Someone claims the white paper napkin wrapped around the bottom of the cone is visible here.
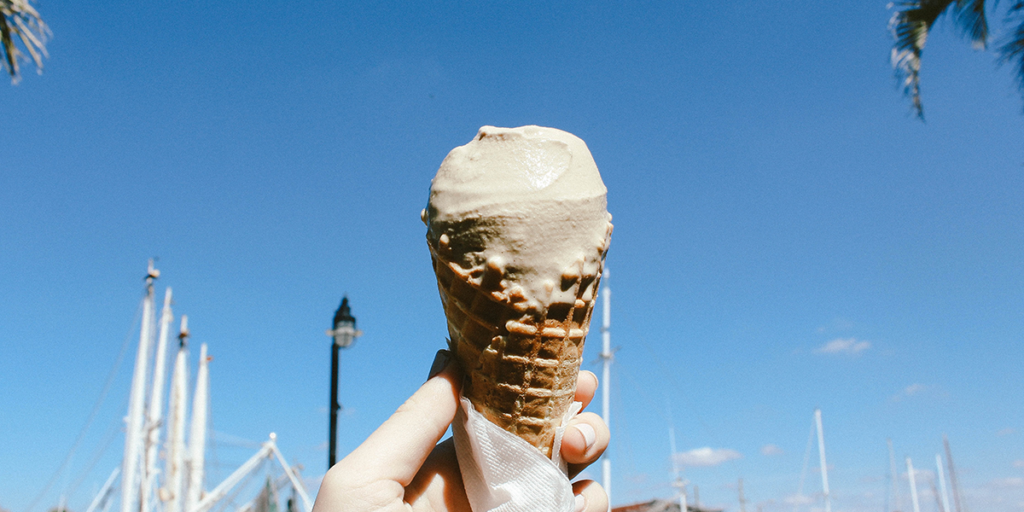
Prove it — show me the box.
[452,397,583,512]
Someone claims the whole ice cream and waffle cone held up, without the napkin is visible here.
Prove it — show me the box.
[423,126,611,457]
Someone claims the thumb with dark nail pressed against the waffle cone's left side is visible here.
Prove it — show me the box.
[338,350,462,486]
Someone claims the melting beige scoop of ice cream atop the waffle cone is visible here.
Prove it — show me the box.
[423,126,611,311]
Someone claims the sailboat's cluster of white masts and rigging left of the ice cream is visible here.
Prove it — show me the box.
[86,260,312,512]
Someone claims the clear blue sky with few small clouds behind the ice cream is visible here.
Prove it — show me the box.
[0,1,1024,512]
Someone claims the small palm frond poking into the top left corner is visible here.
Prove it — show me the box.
[0,0,50,83]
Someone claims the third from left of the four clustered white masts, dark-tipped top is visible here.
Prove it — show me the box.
[161,315,188,512]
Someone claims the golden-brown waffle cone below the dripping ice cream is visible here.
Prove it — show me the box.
[429,240,601,457]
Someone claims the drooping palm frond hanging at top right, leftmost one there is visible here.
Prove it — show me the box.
[889,0,958,120]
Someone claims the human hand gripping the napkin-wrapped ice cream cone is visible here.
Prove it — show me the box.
[313,350,609,512]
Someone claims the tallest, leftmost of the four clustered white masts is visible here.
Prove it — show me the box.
[121,259,160,512]
